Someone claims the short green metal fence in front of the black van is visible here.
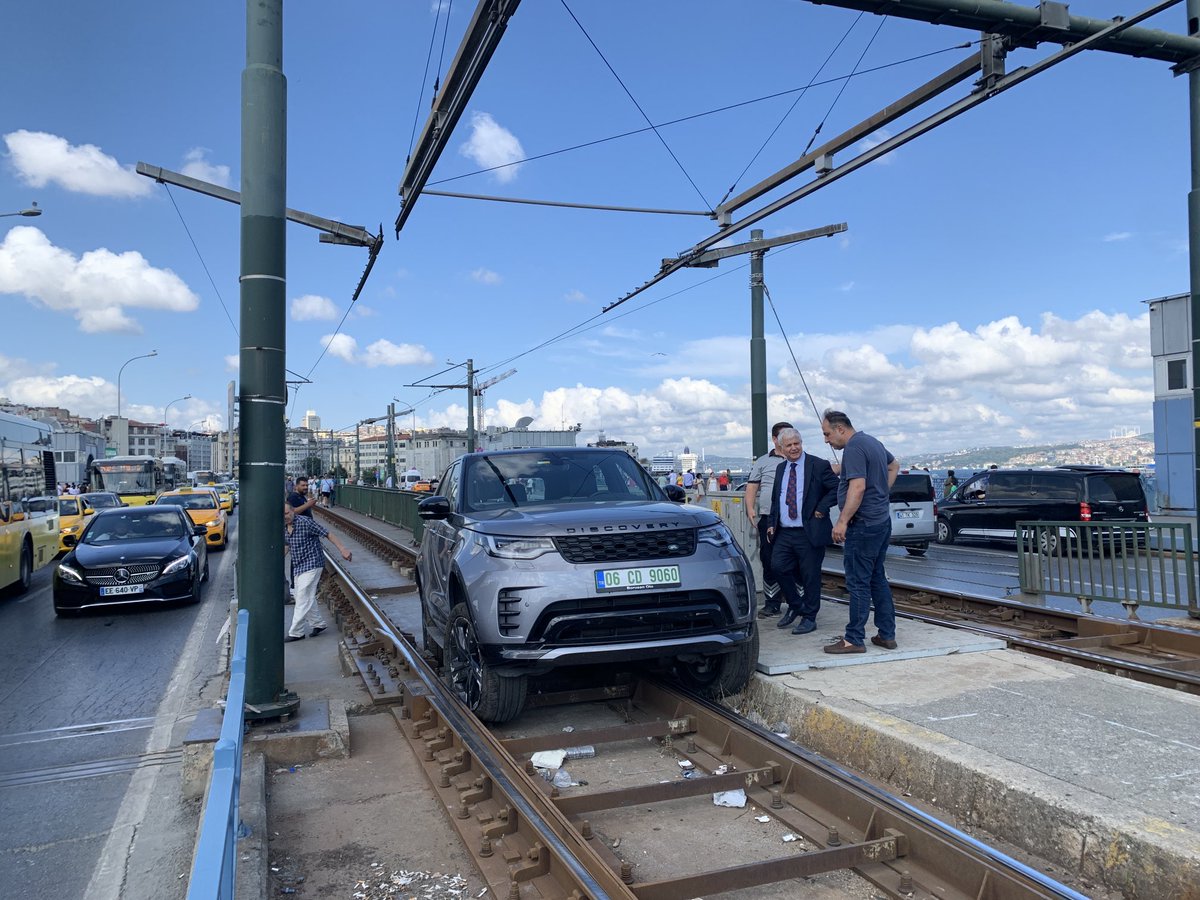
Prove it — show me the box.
[1016,522,1200,619]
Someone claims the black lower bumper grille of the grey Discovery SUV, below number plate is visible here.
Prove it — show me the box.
[529,590,734,646]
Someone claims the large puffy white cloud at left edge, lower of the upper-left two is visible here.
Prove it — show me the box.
[0,226,200,334]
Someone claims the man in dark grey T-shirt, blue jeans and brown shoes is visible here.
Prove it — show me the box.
[821,409,900,653]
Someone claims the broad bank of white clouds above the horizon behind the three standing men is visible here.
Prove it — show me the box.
[504,311,1153,461]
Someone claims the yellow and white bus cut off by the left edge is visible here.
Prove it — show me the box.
[0,413,59,593]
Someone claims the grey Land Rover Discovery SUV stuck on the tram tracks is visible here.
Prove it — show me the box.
[416,448,758,722]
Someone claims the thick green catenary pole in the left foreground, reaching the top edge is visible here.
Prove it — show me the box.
[238,0,300,718]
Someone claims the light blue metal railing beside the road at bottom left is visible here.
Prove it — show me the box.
[187,610,250,900]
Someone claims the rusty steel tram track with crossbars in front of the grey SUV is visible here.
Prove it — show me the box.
[314,511,1082,900]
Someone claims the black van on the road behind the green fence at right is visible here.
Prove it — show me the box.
[936,466,1150,554]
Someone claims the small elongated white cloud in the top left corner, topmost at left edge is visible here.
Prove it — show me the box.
[4,128,154,197]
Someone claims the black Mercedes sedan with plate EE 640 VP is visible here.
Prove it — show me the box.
[54,505,209,616]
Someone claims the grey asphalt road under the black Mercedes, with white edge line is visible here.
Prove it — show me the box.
[0,515,238,900]
